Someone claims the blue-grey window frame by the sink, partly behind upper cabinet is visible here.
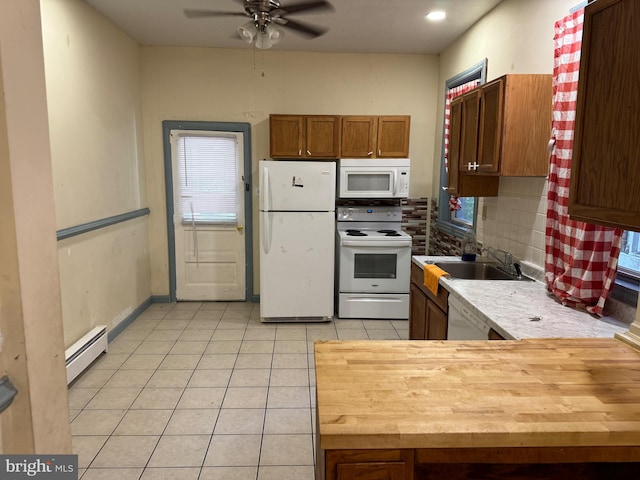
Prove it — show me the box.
[436,58,487,238]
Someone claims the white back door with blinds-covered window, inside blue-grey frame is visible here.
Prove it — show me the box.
[171,130,246,301]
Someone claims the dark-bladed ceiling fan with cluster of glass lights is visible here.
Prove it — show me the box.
[184,0,333,49]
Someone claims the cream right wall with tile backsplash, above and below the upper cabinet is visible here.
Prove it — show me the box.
[433,0,579,267]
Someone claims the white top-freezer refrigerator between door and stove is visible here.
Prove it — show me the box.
[259,160,336,322]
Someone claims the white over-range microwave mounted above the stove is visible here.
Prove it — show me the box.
[337,158,410,198]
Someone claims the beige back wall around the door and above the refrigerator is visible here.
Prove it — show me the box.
[142,47,438,295]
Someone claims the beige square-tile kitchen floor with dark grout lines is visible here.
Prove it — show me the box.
[69,302,408,480]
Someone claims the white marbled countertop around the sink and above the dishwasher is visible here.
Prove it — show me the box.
[412,256,629,340]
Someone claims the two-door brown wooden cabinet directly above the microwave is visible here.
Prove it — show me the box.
[340,115,411,158]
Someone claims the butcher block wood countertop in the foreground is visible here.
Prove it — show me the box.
[315,338,640,454]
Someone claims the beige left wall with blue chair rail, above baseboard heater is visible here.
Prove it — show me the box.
[41,0,151,346]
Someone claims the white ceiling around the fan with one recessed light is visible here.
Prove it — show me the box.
[84,0,502,54]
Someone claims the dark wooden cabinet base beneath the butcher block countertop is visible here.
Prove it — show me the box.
[316,447,640,480]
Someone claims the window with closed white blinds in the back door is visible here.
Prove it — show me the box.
[177,132,238,224]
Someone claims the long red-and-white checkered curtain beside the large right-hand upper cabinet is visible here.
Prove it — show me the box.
[545,9,622,315]
